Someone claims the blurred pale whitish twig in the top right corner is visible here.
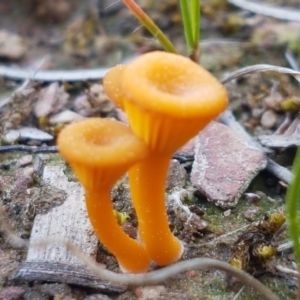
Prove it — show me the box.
[227,0,300,22]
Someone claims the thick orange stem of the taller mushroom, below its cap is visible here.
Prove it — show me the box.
[129,154,183,266]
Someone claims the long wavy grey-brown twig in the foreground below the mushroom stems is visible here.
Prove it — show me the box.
[34,239,279,300]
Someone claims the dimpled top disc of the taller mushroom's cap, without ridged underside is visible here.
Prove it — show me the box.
[121,51,227,119]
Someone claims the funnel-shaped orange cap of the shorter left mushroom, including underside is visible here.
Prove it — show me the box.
[58,118,148,189]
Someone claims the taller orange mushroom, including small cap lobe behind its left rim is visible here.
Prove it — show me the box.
[104,51,228,266]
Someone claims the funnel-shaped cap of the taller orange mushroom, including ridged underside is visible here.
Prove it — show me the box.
[117,51,228,155]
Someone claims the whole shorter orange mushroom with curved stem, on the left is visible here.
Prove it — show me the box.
[58,118,150,273]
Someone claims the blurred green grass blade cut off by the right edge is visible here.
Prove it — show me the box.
[286,147,300,265]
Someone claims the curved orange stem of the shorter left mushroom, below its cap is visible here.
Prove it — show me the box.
[86,189,149,273]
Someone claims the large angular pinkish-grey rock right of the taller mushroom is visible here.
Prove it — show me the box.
[191,122,267,209]
